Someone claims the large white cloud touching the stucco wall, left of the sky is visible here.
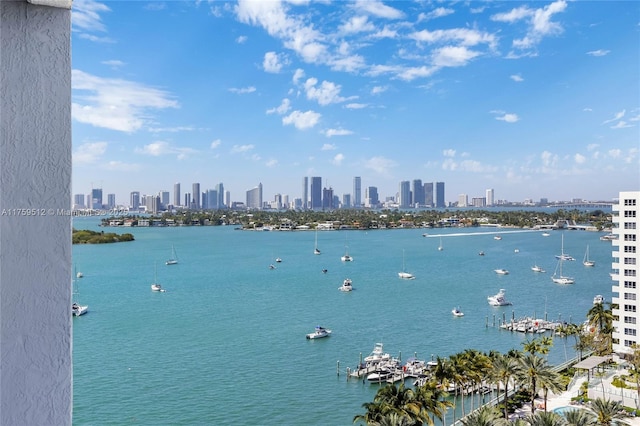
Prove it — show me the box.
[71,70,179,132]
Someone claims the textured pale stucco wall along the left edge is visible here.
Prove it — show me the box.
[0,0,72,426]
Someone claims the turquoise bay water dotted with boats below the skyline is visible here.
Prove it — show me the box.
[73,218,611,425]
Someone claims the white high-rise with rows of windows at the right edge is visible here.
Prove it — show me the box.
[611,191,640,354]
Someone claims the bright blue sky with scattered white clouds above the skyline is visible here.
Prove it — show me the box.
[72,0,640,204]
